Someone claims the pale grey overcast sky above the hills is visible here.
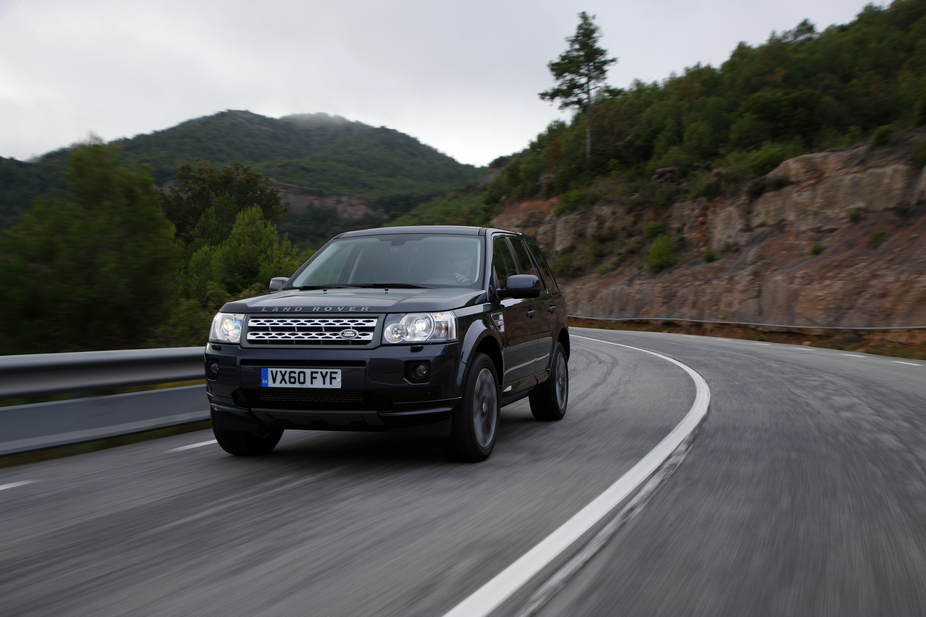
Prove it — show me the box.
[0,0,881,165]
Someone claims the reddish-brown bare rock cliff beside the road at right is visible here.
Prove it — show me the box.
[494,146,926,327]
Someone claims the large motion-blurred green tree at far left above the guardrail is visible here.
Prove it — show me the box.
[0,141,177,354]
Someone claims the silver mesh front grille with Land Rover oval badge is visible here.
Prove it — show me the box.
[247,316,379,347]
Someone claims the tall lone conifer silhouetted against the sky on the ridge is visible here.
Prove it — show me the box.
[540,11,617,158]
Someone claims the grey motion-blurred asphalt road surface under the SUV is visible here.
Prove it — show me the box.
[0,328,926,616]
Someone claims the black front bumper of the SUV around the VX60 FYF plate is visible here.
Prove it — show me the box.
[205,342,463,435]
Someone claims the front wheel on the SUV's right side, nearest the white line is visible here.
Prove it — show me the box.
[444,353,499,463]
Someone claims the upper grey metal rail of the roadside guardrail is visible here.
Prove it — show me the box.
[0,347,205,399]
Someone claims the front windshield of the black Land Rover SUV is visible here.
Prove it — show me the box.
[290,234,485,288]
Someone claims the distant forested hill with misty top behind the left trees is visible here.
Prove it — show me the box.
[0,111,479,229]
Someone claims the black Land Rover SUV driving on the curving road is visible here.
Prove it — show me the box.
[205,226,569,461]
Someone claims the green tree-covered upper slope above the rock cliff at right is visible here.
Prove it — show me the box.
[487,0,926,210]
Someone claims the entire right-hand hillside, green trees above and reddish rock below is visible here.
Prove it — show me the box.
[474,0,926,343]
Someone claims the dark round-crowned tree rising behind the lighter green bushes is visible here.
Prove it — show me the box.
[160,158,287,244]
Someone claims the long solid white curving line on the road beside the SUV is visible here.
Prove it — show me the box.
[444,335,711,617]
